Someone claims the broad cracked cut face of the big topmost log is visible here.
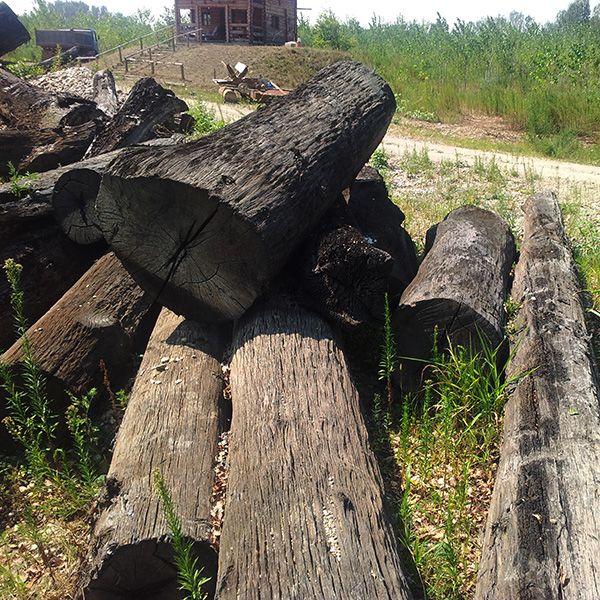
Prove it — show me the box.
[96,174,269,322]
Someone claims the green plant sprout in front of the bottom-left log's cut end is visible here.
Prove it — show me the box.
[152,469,210,600]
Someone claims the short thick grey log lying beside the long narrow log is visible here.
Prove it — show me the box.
[394,206,516,358]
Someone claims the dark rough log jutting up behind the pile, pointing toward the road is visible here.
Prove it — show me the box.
[86,77,188,158]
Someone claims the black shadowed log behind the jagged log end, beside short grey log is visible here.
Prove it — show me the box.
[347,165,418,302]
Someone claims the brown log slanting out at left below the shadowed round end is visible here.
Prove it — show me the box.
[0,253,152,394]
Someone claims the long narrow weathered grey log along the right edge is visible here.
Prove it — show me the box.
[476,192,600,600]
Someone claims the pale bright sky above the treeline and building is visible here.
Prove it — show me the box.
[7,0,584,25]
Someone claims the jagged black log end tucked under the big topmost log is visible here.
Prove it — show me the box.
[290,196,394,333]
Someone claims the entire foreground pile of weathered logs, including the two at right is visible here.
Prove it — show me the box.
[0,61,600,600]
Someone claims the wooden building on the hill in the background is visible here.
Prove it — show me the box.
[175,0,297,44]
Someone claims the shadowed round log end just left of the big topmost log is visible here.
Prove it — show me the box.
[52,169,104,245]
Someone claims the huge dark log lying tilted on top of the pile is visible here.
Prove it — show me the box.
[97,61,395,321]
